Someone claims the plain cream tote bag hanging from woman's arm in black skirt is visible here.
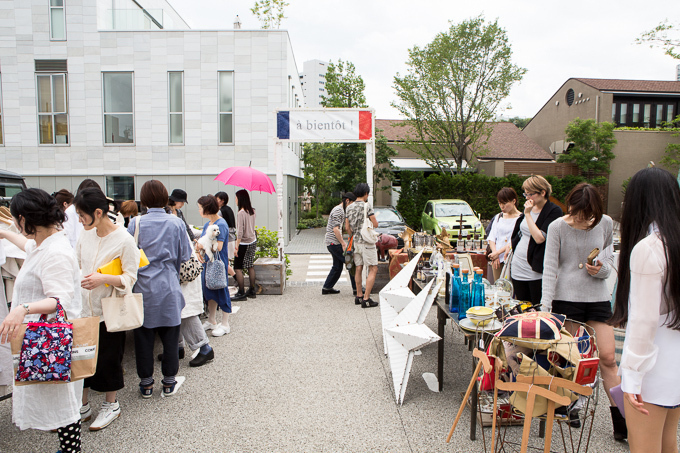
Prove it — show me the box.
[102,216,144,332]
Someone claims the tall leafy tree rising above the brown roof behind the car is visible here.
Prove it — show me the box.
[392,16,526,174]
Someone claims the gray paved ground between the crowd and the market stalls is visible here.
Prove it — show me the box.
[0,287,656,453]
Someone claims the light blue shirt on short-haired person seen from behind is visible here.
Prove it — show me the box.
[128,208,191,329]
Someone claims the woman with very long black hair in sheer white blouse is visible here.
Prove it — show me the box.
[611,168,680,453]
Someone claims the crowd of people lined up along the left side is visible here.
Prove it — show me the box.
[0,179,257,452]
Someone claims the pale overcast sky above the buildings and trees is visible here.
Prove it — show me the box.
[169,0,680,119]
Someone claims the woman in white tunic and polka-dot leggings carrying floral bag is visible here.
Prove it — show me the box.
[0,189,83,452]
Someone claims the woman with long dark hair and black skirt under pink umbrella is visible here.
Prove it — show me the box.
[231,189,257,301]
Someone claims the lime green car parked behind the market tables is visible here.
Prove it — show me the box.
[421,200,484,240]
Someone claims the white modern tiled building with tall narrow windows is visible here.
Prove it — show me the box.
[0,0,304,241]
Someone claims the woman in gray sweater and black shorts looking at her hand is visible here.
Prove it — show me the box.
[541,183,626,440]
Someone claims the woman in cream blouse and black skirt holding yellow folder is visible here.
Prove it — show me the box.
[74,188,139,431]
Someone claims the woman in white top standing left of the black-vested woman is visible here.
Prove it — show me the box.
[487,187,520,280]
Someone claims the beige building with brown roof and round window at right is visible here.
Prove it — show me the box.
[523,78,680,218]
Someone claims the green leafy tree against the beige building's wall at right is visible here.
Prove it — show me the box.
[557,118,616,180]
